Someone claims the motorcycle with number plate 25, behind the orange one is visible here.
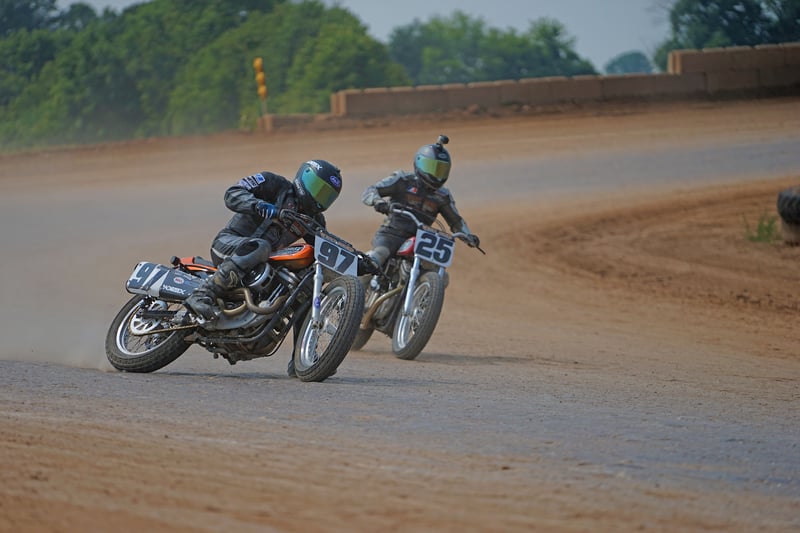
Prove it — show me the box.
[351,204,486,360]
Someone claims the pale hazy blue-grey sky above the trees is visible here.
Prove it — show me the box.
[57,0,669,71]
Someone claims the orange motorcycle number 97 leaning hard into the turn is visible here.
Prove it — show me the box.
[105,210,375,381]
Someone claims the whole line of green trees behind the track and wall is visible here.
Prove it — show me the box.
[0,0,800,149]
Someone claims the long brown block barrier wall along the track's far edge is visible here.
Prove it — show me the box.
[331,43,800,117]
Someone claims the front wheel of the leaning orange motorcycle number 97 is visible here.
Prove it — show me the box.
[292,276,364,381]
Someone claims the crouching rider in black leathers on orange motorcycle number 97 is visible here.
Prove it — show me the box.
[185,159,342,320]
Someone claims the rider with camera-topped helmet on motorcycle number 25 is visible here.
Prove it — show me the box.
[361,135,480,270]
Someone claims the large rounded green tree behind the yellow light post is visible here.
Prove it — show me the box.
[168,1,409,134]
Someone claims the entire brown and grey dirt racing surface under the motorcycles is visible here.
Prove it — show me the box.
[0,99,800,533]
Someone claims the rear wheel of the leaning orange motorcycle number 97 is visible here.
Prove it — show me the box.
[106,296,191,373]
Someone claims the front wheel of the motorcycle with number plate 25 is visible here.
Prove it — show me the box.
[392,272,444,360]
